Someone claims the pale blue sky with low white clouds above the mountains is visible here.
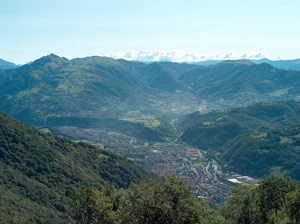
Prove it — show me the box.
[0,0,300,64]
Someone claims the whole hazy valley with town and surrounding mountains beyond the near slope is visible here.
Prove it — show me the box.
[0,54,300,206]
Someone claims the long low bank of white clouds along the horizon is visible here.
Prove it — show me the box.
[106,50,270,62]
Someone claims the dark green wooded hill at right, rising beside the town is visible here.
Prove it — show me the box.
[181,101,300,179]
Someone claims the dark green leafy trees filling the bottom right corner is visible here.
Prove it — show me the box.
[221,176,300,224]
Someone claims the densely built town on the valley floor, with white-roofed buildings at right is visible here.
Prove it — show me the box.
[54,127,258,204]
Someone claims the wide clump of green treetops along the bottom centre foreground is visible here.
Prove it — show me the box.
[67,176,226,224]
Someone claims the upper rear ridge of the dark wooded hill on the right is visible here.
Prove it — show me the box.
[180,101,300,131]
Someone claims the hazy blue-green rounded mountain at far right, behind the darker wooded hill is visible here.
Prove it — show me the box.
[179,60,300,106]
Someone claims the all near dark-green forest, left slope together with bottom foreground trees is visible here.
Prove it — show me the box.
[0,112,300,224]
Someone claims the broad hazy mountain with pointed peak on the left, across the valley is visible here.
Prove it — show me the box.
[0,54,202,126]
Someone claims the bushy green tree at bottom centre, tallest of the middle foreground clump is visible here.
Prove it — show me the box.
[120,176,209,224]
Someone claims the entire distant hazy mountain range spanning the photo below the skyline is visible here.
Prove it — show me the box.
[0,54,300,125]
